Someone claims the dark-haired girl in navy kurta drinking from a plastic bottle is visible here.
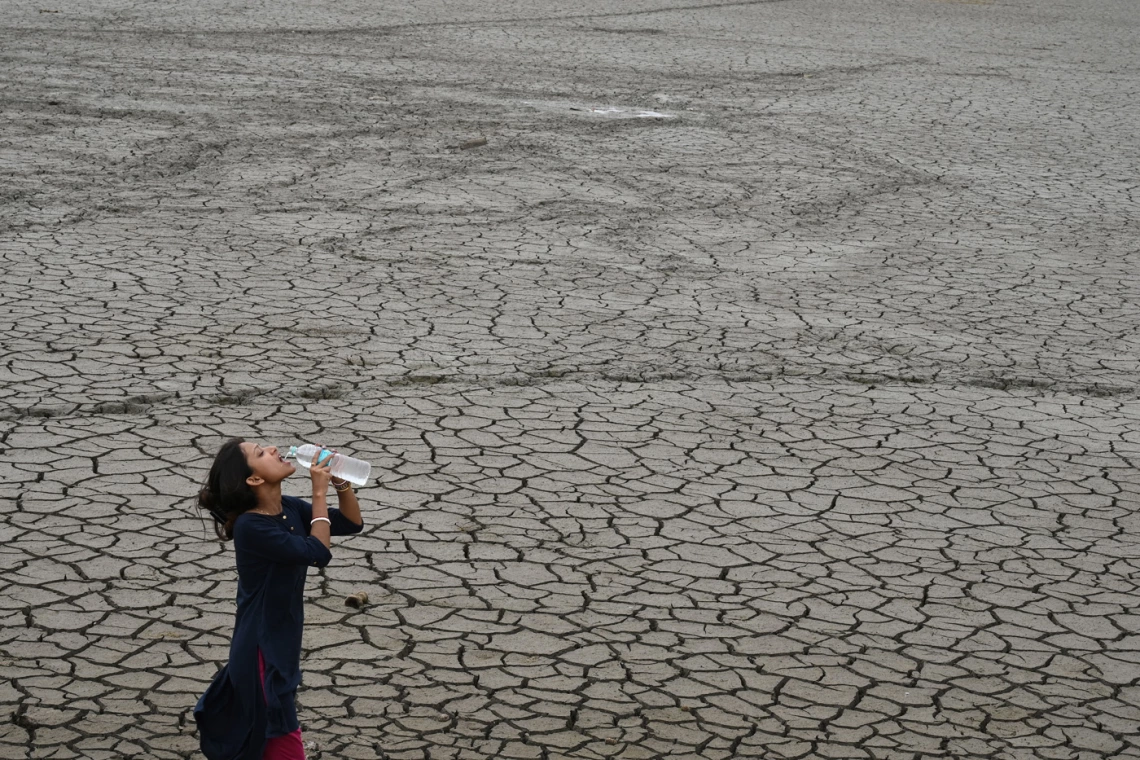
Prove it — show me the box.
[194,439,364,760]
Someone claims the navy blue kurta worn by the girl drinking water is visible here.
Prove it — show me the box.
[194,496,363,760]
